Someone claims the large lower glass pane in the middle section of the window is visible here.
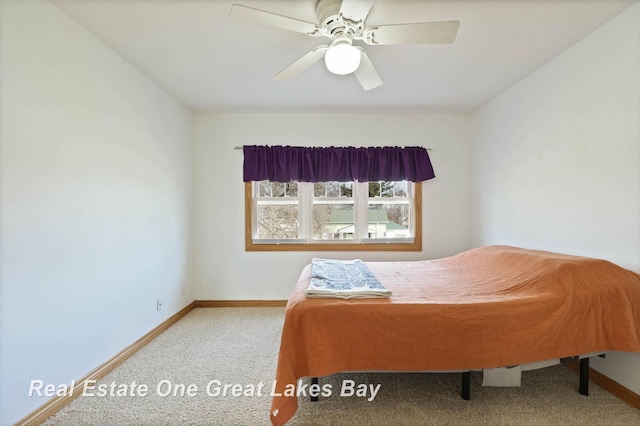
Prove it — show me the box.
[312,203,355,240]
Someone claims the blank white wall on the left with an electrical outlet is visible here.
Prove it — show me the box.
[0,0,194,425]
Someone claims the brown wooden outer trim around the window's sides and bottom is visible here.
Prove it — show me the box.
[244,182,422,252]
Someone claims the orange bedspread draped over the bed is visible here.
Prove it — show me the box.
[271,246,640,425]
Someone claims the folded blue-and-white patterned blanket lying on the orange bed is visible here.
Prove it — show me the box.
[306,258,391,299]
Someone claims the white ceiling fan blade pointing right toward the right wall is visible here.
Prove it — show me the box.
[363,21,460,45]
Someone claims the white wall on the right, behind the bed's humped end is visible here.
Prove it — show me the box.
[472,3,640,393]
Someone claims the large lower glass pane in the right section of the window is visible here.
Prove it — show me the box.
[367,203,411,238]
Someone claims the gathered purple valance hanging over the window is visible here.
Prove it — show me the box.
[242,145,435,182]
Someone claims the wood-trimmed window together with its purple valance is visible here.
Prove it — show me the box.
[242,145,435,251]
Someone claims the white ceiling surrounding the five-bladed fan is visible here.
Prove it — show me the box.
[52,0,635,113]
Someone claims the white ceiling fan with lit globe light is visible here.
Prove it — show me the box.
[229,0,460,90]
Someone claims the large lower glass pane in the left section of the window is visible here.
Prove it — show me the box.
[257,203,298,239]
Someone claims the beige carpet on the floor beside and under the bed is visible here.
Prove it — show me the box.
[45,308,640,426]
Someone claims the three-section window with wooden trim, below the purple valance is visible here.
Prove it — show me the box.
[245,180,422,251]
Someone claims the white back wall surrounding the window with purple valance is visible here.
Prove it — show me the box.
[195,113,470,300]
